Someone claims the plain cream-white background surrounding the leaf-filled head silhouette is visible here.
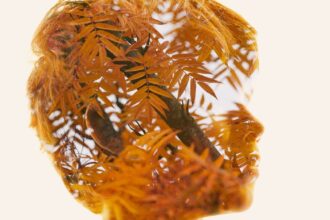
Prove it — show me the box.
[0,0,330,220]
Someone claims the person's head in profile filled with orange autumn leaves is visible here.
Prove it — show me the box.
[28,0,263,220]
